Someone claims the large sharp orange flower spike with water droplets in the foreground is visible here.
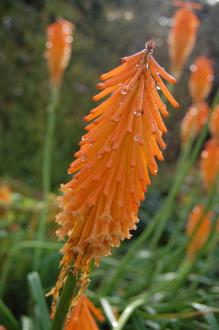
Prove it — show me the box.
[52,42,178,312]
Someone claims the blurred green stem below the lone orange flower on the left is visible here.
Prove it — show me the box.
[34,85,60,269]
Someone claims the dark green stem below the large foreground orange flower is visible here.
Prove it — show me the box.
[52,274,76,330]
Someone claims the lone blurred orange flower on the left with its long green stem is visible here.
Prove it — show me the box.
[34,19,74,269]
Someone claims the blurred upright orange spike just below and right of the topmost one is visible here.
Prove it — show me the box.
[189,56,214,103]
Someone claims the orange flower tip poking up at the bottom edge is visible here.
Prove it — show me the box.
[64,295,104,330]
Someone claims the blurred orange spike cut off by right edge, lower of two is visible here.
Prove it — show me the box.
[200,138,219,190]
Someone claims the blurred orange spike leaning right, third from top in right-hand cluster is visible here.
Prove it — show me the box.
[181,102,210,143]
